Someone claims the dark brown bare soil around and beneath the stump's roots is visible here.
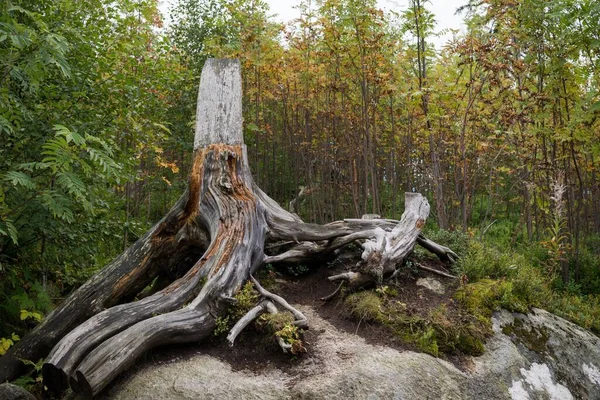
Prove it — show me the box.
[117,253,470,382]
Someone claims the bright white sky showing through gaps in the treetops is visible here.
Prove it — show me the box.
[265,0,468,49]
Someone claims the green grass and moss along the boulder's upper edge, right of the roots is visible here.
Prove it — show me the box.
[344,231,600,356]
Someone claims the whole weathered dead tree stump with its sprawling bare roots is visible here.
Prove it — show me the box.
[0,60,456,397]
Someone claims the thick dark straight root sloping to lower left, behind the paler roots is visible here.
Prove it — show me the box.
[0,193,206,382]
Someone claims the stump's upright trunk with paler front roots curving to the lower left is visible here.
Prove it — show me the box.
[44,62,266,396]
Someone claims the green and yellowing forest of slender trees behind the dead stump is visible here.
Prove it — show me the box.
[0,0,600,382]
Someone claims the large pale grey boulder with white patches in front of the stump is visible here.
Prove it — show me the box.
[102,307,600,400]
